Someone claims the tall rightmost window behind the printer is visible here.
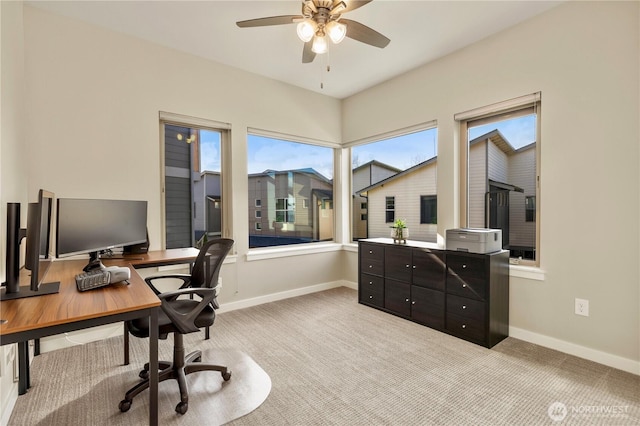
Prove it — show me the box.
[456,93,541,265]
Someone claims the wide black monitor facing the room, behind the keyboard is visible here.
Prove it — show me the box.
[56,198,147,271]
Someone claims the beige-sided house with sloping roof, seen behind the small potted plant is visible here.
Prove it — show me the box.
[358,156,437,242]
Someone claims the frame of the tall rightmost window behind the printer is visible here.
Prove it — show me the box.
[454,92,542,267]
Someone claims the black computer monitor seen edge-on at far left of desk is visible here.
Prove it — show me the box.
[2,189,60,300]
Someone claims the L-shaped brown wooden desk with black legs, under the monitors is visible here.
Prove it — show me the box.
[0,248,198,425]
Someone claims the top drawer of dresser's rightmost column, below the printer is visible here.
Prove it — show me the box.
[447,254,488,300]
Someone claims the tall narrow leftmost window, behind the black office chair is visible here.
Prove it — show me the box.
[160,113,230,249]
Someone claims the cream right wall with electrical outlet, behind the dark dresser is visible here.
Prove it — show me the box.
[343,2,640,374]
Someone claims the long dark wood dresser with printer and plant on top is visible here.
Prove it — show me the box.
[358,238,509,348]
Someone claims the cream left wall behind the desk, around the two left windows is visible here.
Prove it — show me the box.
[24,6,341,302]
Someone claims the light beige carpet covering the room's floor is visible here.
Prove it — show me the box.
[6,287,640,426]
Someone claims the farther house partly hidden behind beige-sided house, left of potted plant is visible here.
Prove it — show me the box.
[351,160,401,240]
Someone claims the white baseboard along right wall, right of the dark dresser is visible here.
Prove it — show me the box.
[509,327,640,375]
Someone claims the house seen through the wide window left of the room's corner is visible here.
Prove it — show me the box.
[249,168,334,247]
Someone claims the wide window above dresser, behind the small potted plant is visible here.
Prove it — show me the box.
[345,122,438,242]
